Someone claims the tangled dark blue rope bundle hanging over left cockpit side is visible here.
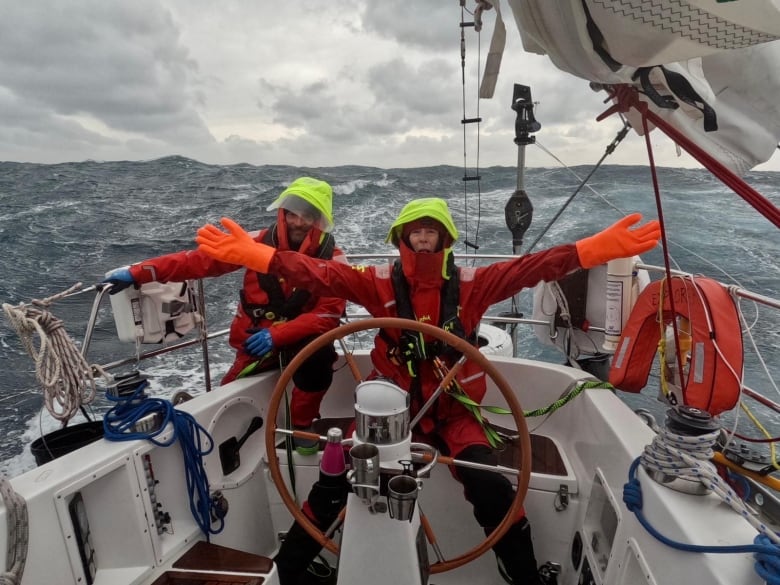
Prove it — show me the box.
[103,380,225,540]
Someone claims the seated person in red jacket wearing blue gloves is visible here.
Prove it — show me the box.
[104,177,346,451]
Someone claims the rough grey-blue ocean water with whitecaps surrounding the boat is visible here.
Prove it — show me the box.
[0,157,780,476]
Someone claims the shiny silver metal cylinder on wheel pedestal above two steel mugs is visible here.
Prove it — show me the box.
[355,380,409,445]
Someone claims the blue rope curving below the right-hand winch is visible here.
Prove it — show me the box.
[623,457,780,585]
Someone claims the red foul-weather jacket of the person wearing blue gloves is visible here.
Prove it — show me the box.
[130,219,347,384]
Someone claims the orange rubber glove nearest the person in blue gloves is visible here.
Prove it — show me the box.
[195,217,276,272]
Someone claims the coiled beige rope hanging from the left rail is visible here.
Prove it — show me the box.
[3,282,108,423]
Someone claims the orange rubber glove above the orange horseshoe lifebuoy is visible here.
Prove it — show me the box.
[575,213,661,268]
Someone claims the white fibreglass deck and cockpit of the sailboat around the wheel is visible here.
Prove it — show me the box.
[0,353,762,585]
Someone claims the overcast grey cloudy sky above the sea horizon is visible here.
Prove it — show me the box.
[0,0,780,170]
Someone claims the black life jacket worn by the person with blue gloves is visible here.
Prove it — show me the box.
[240,224,336,325]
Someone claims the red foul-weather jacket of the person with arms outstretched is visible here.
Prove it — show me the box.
[270,241,580,456]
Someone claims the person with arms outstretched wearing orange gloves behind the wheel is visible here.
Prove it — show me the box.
[196,198,660,585]
